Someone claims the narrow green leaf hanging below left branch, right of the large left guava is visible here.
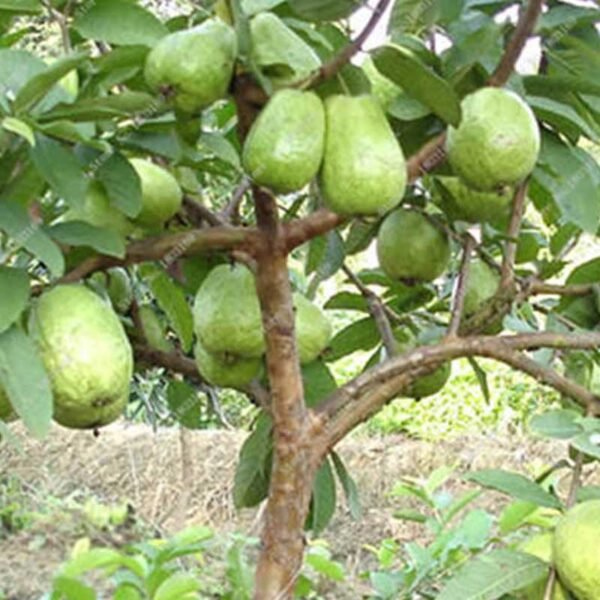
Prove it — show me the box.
[140,265,194,352]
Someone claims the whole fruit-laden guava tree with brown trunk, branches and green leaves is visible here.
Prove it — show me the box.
[0,0,600,599]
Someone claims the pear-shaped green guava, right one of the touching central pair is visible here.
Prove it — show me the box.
[321,96,407,215]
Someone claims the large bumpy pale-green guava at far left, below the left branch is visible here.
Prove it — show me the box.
[29,285,133,429]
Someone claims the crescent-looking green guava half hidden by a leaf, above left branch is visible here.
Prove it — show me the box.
[129,158,183,227]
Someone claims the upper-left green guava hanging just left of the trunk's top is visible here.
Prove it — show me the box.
[144,18,237,113]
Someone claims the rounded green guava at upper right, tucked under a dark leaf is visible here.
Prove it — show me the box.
[446,87,540,191]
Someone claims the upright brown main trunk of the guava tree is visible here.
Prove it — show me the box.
[254,190,315,600]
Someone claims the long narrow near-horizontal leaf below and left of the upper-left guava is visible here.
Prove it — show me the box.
[39,91,159,122]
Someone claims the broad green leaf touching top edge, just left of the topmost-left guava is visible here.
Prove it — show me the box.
[73,0,168,46]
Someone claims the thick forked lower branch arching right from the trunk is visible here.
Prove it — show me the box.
[316,332,600,451]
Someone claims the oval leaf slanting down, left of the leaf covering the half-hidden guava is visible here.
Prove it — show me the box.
[29,134,88,207]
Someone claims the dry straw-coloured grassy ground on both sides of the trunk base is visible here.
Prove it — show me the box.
[0,424,596,600]
